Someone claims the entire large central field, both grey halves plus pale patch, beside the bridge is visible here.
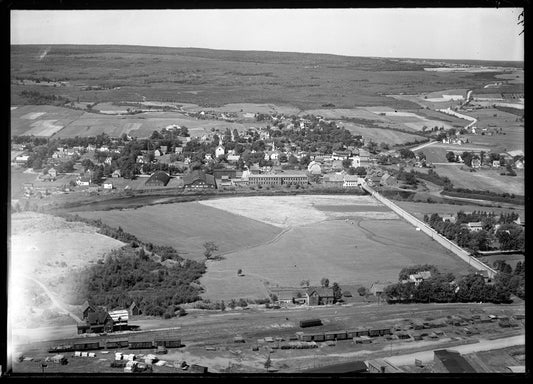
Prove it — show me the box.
[68,195,472,300]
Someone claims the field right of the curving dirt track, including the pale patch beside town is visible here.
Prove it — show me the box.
[194,196,466,300]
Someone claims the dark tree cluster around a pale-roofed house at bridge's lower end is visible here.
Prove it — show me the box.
[384,266,511,303]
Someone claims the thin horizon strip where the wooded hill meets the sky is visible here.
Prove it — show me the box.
[10,43,524,63]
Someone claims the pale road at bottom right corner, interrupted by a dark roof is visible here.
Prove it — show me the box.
[386,335,526,366]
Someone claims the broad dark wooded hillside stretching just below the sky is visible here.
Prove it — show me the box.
[11,45,516,110]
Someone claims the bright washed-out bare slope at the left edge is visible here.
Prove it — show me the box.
[9,212,123,327]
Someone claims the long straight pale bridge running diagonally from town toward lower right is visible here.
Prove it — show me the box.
[362,185,496,279]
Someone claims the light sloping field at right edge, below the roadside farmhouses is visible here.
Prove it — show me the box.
[428,165,525,196]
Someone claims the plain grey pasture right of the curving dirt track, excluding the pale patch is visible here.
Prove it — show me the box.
[200,216,467,300]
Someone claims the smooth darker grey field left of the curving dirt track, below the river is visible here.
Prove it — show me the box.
[71,202,281,260]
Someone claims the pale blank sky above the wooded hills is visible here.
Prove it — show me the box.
[11,8,524,61]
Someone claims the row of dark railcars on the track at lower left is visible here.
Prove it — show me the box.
[48,339,182,353]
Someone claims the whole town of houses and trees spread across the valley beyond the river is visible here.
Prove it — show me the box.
[12,108,525,197]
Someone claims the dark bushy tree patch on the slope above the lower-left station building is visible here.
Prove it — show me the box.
[67,245,205,317]
